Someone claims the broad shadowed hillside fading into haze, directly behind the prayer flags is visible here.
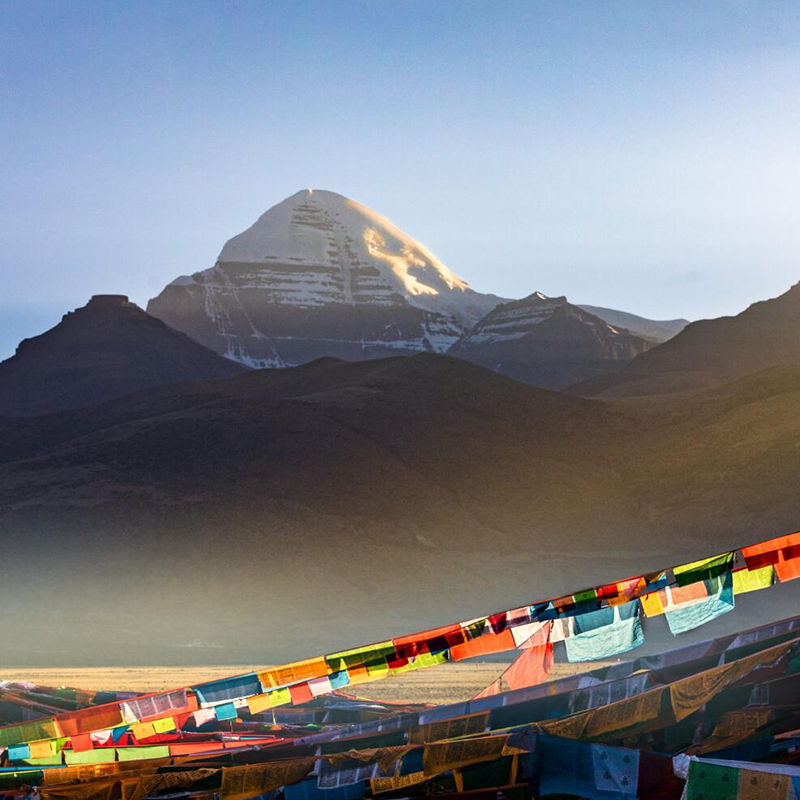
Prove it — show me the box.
[0,355,800,663]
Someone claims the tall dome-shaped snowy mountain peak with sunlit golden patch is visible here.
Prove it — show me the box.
[147,189,501,367]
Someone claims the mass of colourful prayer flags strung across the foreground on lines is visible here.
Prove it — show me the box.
[0,532,800,800]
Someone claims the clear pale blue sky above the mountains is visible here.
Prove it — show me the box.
[0,0,800,357]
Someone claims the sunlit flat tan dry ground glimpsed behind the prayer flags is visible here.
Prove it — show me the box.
[0,663,602,704]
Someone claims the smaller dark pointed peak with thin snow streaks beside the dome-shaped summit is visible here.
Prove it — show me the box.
[448,292,653,389]
